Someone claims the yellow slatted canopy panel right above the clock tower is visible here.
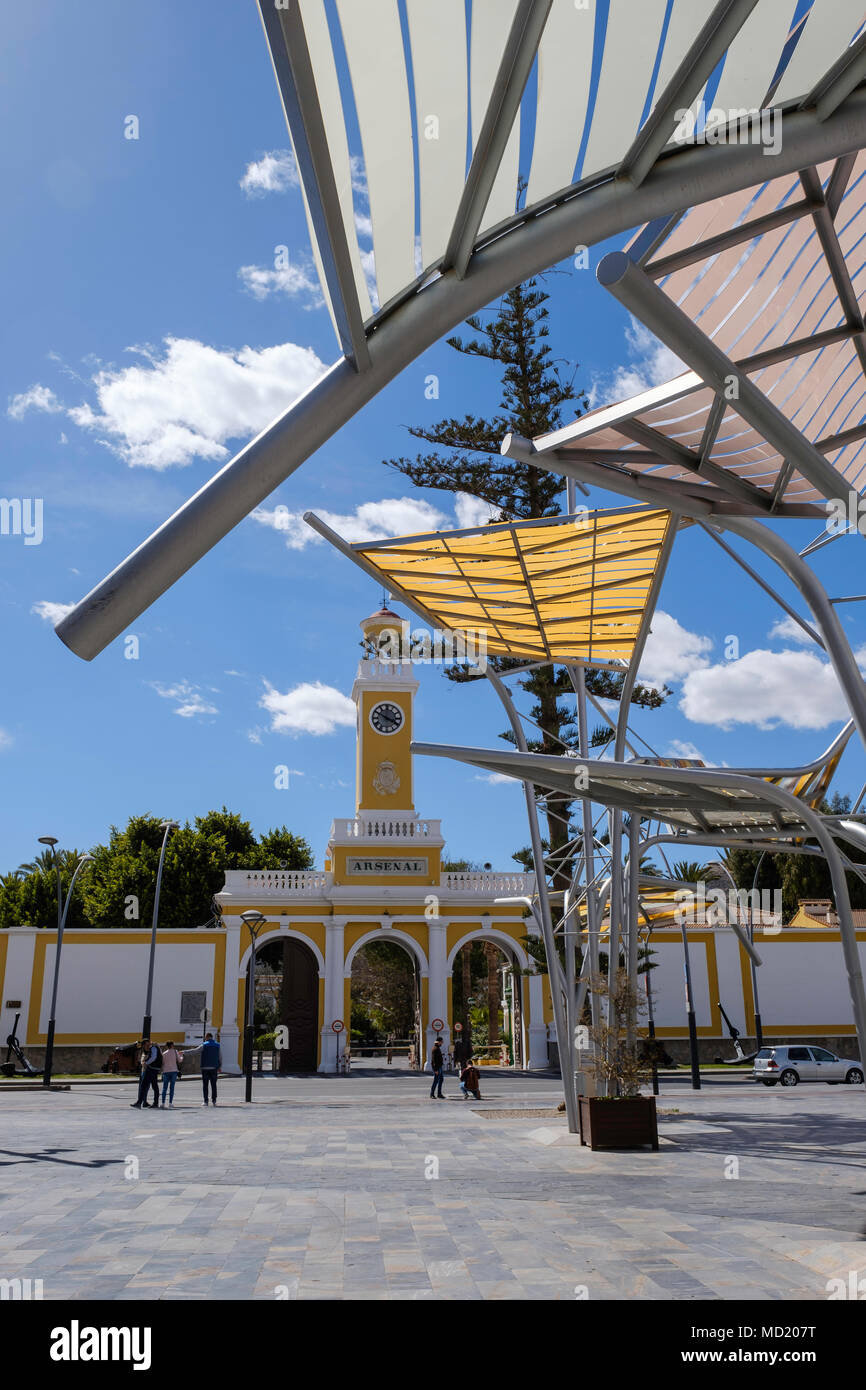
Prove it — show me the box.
[352,507,673,663]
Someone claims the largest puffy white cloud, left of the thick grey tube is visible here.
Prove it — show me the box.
[68,338,324,468]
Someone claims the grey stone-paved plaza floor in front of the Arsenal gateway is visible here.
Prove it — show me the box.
[0,1065,866,1300]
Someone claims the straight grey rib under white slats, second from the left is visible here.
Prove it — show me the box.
[442,0,553,279]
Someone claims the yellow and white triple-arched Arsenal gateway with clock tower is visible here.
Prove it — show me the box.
[217,609,550,1072]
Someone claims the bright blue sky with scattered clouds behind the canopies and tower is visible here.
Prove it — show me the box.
[0,0,866,869]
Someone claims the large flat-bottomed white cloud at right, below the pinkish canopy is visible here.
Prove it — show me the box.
[680,651,850,728]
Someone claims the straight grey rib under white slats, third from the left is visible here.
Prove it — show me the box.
[617,0,758,188]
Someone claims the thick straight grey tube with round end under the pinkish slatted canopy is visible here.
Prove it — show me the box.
[598,252,856,499]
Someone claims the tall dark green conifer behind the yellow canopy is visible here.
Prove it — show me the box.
[384,279,667,887]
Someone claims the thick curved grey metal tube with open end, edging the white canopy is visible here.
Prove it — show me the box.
[57,92,866,660]
